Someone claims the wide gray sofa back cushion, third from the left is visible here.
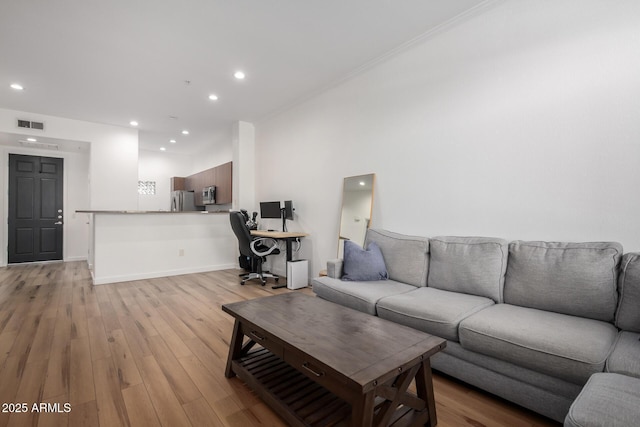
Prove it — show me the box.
[504,241,622,322]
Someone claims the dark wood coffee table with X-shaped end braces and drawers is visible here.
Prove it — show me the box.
[222,292,446,426]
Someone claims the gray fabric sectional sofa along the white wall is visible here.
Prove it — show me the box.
[312,229,640,426]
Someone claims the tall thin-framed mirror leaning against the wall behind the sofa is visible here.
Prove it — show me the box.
[338,173,376,258]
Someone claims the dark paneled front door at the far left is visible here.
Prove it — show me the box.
[8,154,63,263]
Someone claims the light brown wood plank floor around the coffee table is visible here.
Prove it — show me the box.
[0,262,557,427]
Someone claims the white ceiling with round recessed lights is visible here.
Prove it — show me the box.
[0,0,484,153]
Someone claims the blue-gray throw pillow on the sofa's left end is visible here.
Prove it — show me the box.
[342,240,389,282]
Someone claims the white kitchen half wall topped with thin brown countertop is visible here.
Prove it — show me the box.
[76,210,238,285]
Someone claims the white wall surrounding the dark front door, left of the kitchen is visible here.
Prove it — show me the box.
[0,109,138,265]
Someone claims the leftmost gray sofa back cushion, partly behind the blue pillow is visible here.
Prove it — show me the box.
[364,228,429,286]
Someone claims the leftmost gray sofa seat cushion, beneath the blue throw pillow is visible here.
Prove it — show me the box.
[311,276,416,316]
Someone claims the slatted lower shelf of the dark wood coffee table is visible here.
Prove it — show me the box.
[232,347,425,427]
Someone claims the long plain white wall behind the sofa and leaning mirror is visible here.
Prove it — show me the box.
[256,0,640,275]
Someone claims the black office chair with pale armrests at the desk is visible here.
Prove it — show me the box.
[229,212,280,286]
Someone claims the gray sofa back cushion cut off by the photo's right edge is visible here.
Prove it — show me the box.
[616,252,640,332]
